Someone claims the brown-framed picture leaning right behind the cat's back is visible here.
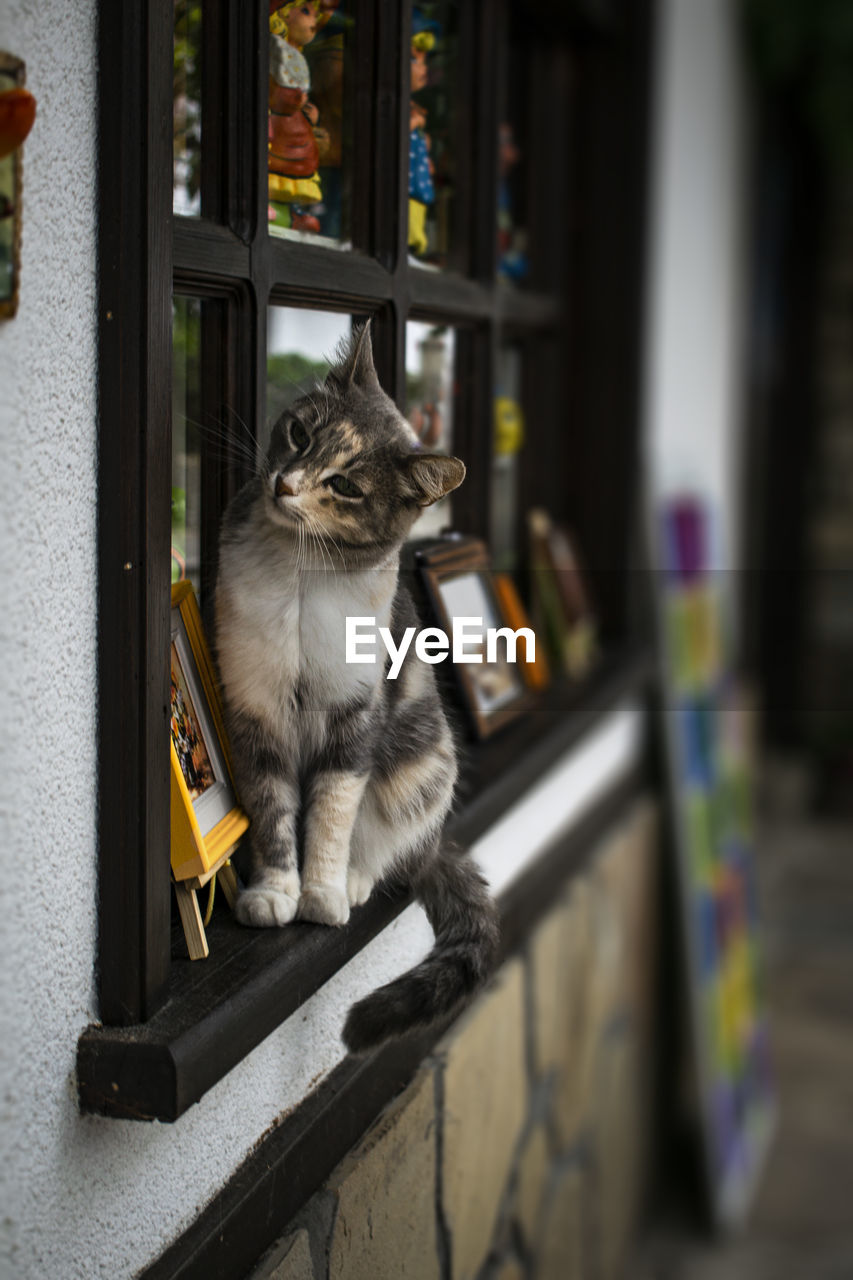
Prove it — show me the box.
[416,539,532,739]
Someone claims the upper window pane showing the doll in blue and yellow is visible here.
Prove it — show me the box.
[409,3,465,268]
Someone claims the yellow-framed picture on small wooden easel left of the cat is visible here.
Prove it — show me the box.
[169,581,248,881]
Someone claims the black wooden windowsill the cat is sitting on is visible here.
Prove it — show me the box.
[77,640,652,1120]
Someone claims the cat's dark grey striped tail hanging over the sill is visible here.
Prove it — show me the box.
[343,849,500,1053]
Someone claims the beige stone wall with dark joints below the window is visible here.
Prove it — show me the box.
[252,800,658,1280]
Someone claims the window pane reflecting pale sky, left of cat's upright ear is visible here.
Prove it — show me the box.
[264,306,352,447]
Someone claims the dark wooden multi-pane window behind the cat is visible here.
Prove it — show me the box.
[94,0,648,1049]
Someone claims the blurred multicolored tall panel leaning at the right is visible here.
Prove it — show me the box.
[661,497,774,1225]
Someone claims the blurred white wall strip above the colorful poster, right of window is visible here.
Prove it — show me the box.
[646,0,748,568]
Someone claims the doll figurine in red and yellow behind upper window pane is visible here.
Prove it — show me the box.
[269,0,323,232]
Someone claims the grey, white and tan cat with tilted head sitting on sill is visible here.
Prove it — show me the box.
[214,323,498,1052]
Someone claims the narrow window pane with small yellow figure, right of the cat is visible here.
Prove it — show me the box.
[491,343,524,572]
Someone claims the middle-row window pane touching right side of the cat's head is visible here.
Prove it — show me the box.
[406,320,456,538]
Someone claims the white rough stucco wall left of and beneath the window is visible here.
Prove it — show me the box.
[0,10,639,1280]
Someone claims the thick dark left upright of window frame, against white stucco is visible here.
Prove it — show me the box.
[99,0,173,1024]
